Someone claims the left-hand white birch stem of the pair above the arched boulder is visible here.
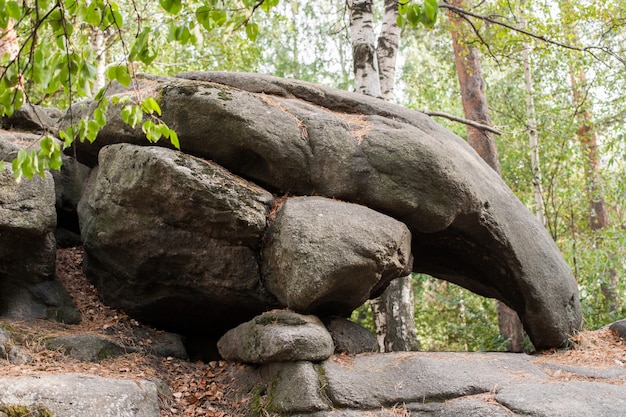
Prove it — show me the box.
[348,0,380,97]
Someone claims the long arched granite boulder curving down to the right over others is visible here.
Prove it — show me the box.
[66,73,582,348]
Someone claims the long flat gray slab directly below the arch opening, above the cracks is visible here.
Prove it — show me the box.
[323,352,547,409]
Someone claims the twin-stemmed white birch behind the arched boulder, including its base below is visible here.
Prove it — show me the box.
[348,0,419,352]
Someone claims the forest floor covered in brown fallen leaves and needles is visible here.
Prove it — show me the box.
[0,248,626,417]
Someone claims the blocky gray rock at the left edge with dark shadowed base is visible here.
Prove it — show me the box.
[0,166,80,324]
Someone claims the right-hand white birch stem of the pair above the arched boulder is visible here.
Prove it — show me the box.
[376,0,400,101]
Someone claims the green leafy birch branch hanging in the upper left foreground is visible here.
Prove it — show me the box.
[0,0,279,181]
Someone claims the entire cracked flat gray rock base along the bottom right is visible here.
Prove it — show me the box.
[252,352,626,417]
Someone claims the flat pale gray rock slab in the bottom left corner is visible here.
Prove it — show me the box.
[0,374,160,417]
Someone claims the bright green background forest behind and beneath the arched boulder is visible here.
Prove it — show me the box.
[0,0,626,350]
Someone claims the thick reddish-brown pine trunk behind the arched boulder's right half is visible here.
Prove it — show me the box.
[448,0,524,352]
